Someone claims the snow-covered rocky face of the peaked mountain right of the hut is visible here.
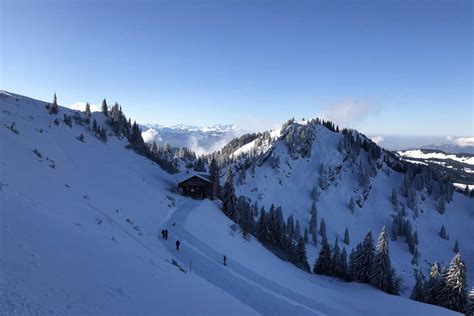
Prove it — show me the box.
[228,122,474,296]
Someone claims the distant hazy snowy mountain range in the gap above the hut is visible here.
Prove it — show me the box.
[137,124,243,155]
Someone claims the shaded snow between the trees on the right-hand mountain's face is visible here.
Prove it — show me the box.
[232,121,474,297]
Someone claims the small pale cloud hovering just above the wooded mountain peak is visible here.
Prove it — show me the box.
[322,99,374,126]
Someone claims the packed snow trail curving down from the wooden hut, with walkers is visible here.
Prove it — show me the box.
[161,200,345,315]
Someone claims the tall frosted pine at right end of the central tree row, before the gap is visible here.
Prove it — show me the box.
[370,226,396,294]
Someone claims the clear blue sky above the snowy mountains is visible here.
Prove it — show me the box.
[0,0,474,136]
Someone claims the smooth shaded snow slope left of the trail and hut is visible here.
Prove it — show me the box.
[0,93,253,315]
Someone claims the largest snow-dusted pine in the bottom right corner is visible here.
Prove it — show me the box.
[441,253,467,313]
